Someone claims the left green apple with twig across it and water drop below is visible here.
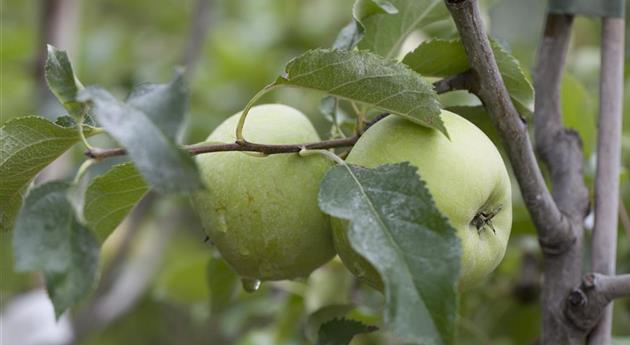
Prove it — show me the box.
[192,104,335,281]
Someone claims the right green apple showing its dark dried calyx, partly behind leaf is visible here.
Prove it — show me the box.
[332,110,512,291]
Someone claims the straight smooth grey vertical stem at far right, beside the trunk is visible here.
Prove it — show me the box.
[587,18,625,345]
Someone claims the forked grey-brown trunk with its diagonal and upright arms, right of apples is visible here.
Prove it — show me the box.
[446,0,588,345]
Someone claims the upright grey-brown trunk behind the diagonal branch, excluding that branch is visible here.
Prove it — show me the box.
[534,14,588,344]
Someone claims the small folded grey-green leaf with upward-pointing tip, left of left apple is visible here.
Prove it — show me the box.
[126,70,188,140]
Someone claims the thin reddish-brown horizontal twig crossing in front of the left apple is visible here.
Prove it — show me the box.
[85,113,389,160]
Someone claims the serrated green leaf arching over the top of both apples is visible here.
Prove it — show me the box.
[274,49,447,135]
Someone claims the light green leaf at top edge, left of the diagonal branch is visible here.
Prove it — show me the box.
[353,0,450,58]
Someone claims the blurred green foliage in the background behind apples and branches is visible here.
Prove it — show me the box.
[0,0,630,345]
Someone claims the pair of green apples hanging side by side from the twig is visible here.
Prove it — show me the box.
[193,104,512,291]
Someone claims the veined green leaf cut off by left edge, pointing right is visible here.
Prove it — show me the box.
[0,116,89,230]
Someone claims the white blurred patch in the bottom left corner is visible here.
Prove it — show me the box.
[0,289,73,345]
